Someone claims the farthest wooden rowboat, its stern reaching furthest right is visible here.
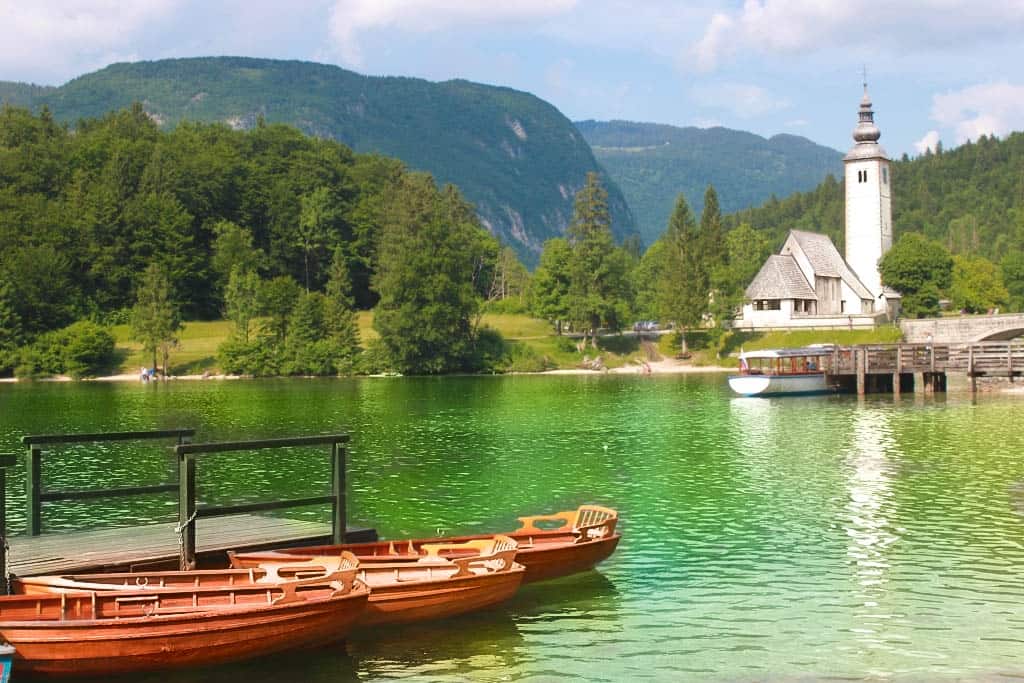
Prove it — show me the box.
[260,531,622,591]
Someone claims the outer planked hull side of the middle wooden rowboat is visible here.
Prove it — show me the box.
[356,567,523,626]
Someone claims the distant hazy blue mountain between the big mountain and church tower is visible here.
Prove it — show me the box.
[575,121,843,244]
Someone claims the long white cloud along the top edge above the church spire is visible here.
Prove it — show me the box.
[690,0,1024,71]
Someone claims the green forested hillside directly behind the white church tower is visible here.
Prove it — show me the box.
[725,133,1024,262]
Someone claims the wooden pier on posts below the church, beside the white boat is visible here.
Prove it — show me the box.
[822,341,1024,395]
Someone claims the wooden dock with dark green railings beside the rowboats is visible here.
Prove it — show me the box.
[0,429,377,584]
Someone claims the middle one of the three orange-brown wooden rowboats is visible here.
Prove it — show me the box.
[228,536,524,626]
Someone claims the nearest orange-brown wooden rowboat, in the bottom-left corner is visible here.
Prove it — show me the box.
[0,555,370,676]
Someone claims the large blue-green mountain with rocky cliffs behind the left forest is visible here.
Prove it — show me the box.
[0,57,635,263]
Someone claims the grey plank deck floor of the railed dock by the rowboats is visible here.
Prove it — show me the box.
[8,514,377,577]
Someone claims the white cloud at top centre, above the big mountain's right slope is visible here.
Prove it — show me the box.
[329,0,579,67]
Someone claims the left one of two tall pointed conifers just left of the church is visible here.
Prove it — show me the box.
[658,193,710,353]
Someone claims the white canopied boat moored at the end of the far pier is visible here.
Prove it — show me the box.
[729,344,834,396]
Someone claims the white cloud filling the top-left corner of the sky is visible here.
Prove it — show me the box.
[0,0,177,80]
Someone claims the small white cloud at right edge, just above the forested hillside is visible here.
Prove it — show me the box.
[932,81,1024,144]
